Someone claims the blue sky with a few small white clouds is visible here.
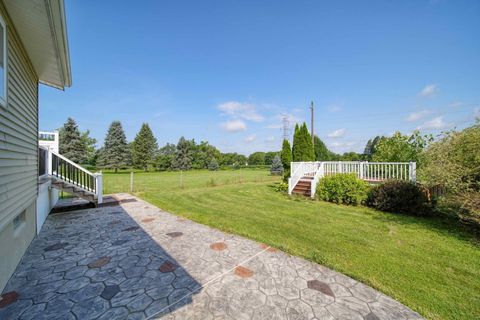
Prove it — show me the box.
[40,0,480,154]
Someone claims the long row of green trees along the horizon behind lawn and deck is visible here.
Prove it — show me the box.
[59,118,440,175]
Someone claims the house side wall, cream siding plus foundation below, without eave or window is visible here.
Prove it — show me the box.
[0,1,38,291]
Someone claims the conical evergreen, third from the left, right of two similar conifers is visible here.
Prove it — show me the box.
[132,123,158,171]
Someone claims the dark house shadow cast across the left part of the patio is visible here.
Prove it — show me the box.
[0,199,201,319]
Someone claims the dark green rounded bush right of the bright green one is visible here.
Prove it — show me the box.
[366,180,432,216]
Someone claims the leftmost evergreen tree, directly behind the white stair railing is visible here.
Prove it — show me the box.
[59,118,87,163]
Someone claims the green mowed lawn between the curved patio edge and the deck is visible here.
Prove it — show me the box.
[104,170,480,319]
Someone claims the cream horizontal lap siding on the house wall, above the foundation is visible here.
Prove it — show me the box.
[0,2,38,230]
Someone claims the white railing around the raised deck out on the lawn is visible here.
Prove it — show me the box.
[288,161,417,197]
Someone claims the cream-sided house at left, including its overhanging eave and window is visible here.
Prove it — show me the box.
[0,0,93,292]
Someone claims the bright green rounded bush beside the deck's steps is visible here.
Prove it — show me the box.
[316,173,369,205]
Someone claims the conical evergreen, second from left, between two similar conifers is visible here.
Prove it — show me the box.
[102,121,130,172]
